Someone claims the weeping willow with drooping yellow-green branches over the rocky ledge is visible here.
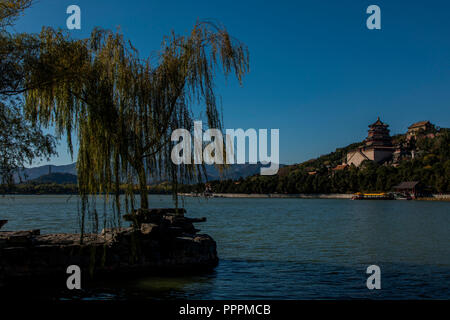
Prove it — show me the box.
[25,23,249,238]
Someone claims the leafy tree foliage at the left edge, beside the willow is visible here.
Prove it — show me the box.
[0,0,55,185]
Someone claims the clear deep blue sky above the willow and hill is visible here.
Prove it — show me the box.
[12,0,450,164]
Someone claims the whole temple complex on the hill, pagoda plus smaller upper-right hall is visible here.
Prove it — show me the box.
[334,117,436,170]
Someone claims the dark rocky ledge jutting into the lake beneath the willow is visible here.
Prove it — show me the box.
[0,210,218,286]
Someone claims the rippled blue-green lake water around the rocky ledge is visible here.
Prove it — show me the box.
[0,195,450,299]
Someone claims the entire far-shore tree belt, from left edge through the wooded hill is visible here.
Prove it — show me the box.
[0,128,450,199]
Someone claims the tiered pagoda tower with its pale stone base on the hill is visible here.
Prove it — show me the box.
[346,117,395,167]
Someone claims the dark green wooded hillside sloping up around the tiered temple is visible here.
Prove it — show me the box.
[184,128,450,194]
